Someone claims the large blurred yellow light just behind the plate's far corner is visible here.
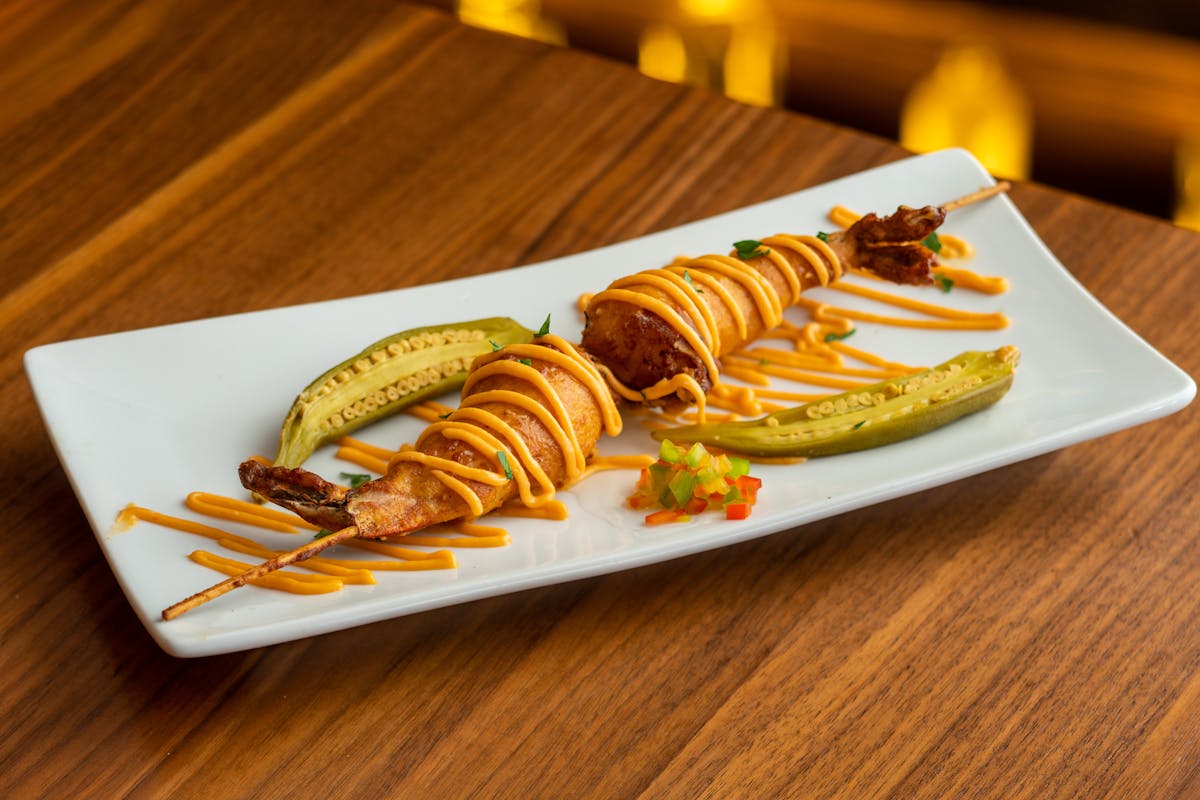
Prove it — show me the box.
[900,46,1033,178]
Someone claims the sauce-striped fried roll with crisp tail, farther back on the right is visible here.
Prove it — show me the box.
[582,206,946,405]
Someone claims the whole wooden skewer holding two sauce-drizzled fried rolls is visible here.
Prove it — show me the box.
[162,181,1009,620]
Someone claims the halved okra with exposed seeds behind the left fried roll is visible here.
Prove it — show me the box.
[275,317,533,467]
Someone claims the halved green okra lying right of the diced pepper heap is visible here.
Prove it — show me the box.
[653,345,1020,457]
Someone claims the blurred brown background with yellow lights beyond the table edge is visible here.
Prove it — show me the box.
[444,0,1200,228]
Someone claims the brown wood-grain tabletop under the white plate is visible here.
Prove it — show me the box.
[0,0,1200,799]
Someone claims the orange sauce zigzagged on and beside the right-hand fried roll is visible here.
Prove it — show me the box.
[580,206,1009,427]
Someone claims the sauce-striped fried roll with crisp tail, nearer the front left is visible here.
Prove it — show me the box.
[239,335,620,539]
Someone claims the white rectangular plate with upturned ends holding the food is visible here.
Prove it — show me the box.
[25,150,1195,656]
